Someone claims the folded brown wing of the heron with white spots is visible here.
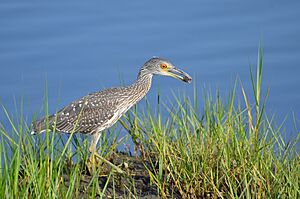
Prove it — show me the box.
[55,88,126,133]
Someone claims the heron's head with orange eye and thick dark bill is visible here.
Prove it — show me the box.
[139,57,192,83]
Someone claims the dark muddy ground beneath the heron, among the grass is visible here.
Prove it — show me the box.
[63,153,181,199]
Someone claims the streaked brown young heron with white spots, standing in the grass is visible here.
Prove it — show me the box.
[33,57,192,153]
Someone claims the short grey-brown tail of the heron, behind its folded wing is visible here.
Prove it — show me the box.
[31,115,55,134]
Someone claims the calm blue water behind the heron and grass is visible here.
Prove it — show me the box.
[0,0,300,148]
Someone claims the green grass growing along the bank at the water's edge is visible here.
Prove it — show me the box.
[0,48,300,198]
